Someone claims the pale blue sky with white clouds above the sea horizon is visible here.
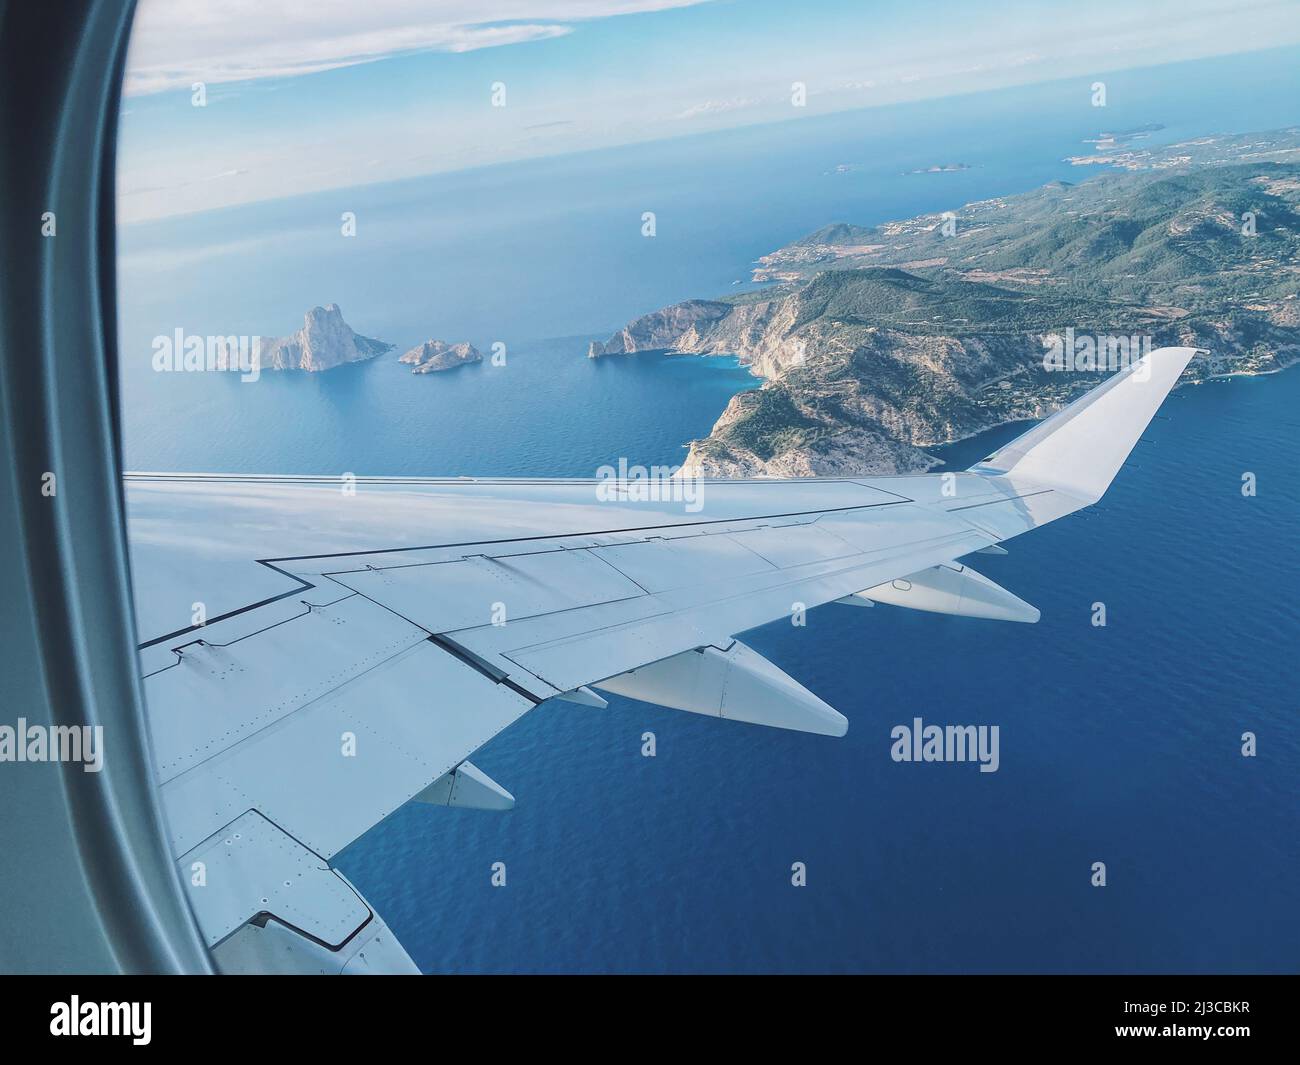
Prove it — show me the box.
[118,0,1300,224]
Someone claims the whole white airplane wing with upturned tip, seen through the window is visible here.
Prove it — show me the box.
[126,348,1196,971]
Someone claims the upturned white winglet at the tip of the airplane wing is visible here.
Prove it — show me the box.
[971,347,1201,503]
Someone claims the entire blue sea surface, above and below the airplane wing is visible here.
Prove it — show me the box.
[120,52,1300,971]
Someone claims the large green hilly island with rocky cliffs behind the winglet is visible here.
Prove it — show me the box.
[588,129,1300,477]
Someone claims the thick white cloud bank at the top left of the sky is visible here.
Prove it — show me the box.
[125,0,703,95]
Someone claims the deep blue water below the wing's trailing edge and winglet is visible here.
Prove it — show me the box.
[330,372,1300,971]
